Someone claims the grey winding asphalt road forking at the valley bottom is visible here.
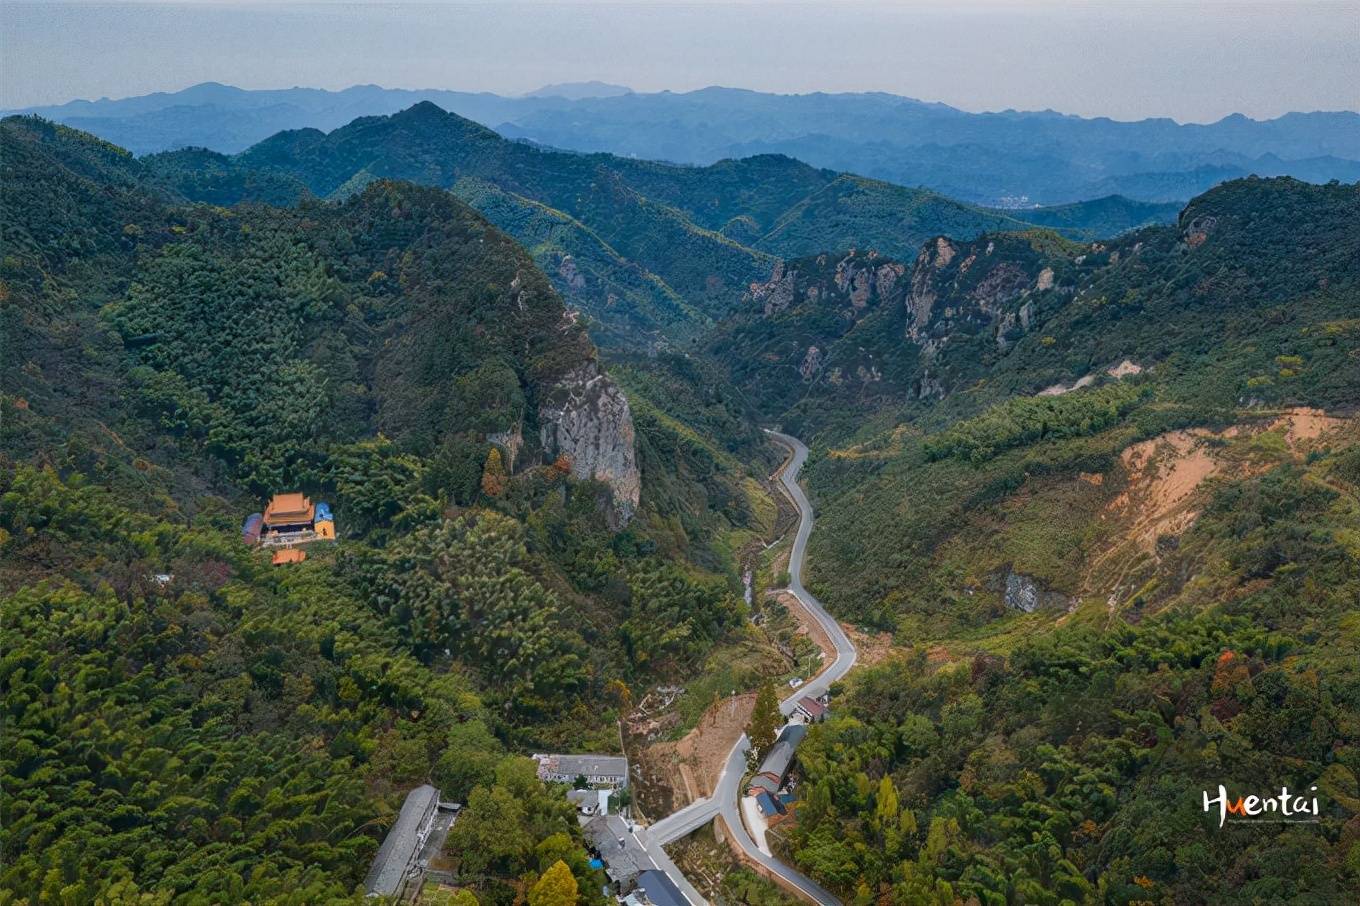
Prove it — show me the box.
[636,431,858,906]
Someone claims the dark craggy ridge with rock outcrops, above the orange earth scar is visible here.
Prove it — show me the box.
[706,180,1360,439]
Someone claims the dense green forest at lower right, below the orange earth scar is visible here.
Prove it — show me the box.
[790,443,1360,905]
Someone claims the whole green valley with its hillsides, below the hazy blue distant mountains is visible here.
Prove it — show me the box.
[0,82,1360,906]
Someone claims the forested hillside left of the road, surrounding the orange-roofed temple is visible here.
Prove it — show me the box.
[0,118,770,903]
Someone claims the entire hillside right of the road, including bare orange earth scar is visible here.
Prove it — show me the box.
[782,180,1360,905]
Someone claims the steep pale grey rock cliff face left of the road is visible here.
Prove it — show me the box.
[539,360,642,528]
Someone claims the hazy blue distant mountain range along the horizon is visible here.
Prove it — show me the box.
[20,83,1360,207]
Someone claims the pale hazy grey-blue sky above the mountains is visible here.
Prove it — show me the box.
[0,0,1360,122]
